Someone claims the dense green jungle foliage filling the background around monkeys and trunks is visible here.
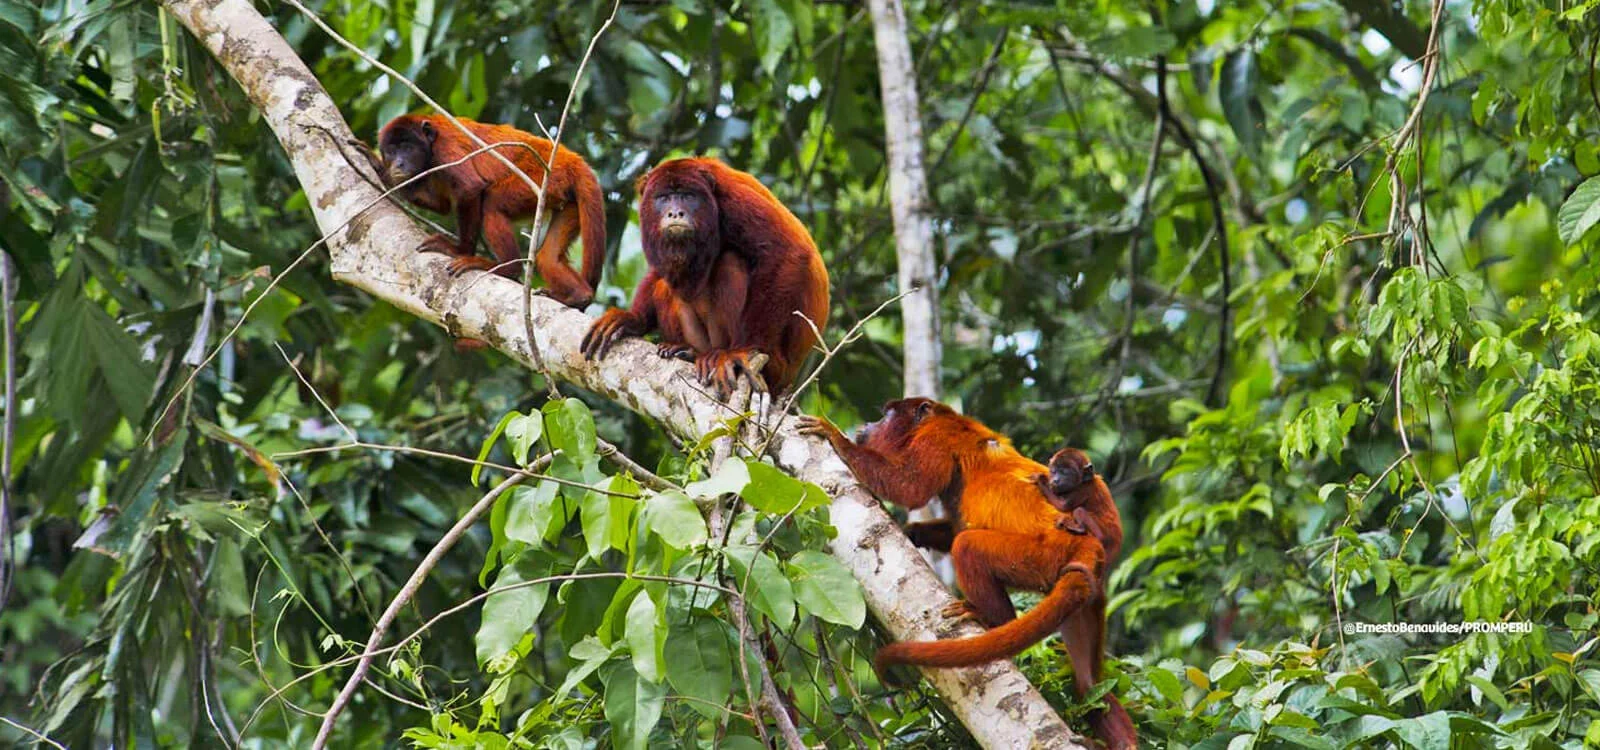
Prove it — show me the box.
[0,0,1600,748]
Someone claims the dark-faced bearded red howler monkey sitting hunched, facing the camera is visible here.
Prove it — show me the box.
[582,158,827,398]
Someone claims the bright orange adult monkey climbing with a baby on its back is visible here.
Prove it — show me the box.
[798,398,1138,748]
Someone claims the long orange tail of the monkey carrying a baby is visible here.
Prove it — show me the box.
[872,571,1094,673]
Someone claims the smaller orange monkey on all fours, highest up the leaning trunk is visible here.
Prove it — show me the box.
[378,115,605,309]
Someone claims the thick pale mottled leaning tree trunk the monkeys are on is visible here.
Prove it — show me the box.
[163,0,1083,748]
